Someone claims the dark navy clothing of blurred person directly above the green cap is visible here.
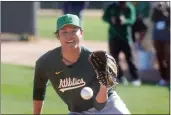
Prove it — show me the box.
[63,1,88,20]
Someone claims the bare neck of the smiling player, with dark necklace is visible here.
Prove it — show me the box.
[62,47,81,65]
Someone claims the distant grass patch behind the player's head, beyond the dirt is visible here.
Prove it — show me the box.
[38,16,108,41]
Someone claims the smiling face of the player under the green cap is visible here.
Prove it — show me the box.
[57,25,83,48]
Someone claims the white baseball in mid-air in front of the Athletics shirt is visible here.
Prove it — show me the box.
[81,87,93,100]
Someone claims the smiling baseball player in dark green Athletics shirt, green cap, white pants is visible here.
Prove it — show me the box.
[33,14,130,114]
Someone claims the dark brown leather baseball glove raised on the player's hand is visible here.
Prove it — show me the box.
[88,51,117,90]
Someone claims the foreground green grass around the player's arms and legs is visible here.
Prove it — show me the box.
[1,64,169,114]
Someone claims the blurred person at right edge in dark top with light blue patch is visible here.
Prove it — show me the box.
[151,2,170,86]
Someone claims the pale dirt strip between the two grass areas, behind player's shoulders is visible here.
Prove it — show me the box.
[1,40,107,66]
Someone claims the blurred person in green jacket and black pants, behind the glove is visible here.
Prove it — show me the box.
[102,1,141,86]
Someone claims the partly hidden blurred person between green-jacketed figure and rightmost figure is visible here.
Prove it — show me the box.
[132,1,150,49]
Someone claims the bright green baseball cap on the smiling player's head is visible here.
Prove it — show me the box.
[56,14,81,32]
